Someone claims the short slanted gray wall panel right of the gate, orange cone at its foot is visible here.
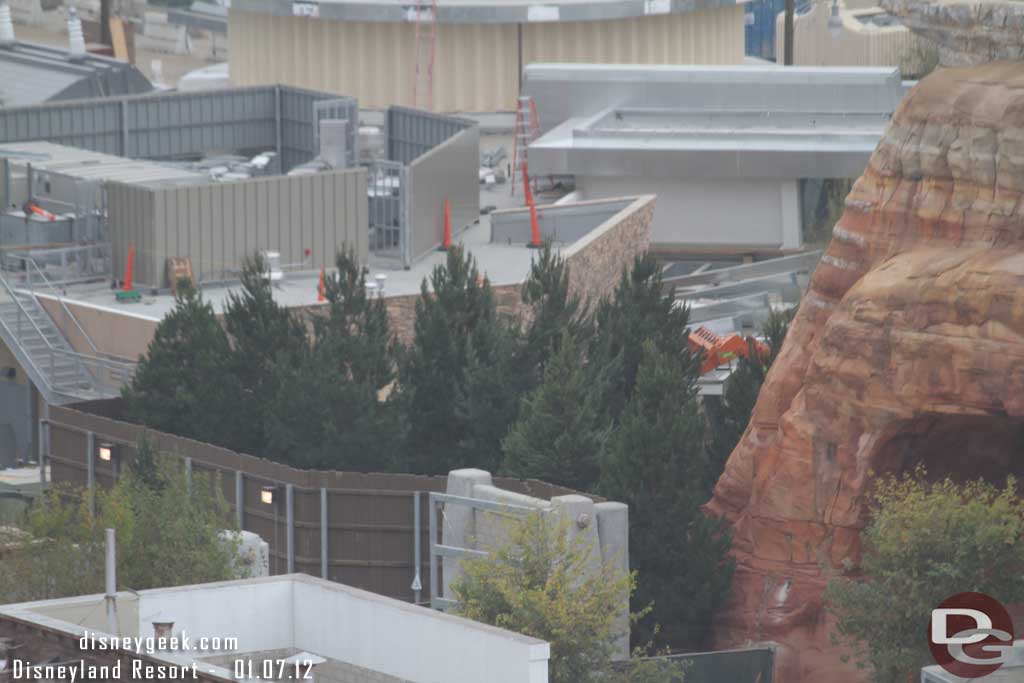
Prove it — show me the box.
[408,125,480,260]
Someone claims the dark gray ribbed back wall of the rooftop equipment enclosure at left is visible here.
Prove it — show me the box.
[0,86,354,171]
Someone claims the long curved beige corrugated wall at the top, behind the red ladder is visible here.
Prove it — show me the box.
[228,5,743,112]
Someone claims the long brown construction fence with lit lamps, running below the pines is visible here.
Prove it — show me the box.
[48,399,585,600]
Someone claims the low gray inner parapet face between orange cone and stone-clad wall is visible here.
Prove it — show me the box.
[490,198,634,245]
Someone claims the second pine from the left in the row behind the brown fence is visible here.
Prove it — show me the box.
[226,254,308,460]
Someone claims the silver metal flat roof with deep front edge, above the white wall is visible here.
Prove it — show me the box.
[529,108,889,179]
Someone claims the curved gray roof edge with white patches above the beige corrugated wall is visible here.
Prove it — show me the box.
[232,0,748,24]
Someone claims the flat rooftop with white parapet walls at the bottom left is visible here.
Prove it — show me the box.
[0,574,550,683]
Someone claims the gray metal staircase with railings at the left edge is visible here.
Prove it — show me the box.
[0,259,135,405]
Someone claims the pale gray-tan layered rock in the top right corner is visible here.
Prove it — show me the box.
[880,0,1024,67]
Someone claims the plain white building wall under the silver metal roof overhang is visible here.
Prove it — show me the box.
[577,176,802,249]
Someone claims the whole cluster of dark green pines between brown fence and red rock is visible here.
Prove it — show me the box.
[125,246,745,648]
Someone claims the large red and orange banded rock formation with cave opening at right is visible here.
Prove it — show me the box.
[708,62,1024,683]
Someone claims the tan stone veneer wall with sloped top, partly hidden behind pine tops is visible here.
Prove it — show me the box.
[385,195,654,342]
